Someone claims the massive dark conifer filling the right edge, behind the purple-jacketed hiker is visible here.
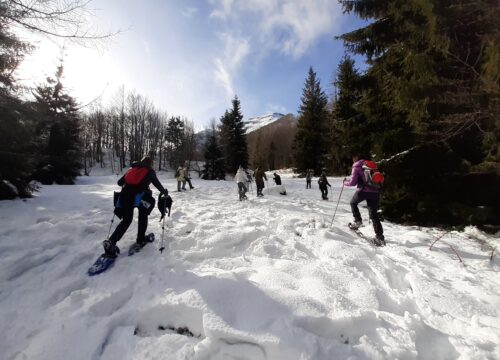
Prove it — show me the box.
[341,0,500,223]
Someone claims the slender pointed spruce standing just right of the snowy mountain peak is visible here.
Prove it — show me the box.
[293,67,328,174]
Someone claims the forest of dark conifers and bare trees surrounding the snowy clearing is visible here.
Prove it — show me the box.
[0,0,500,229]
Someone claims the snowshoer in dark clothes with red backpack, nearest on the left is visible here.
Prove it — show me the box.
[102,156,168,258]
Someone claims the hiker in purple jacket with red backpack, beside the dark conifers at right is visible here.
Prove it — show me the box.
[344,155,385,245]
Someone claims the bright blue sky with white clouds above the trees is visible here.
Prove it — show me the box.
[16,0,363,127]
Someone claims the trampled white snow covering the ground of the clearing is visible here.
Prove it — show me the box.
[0,174,500,360]
